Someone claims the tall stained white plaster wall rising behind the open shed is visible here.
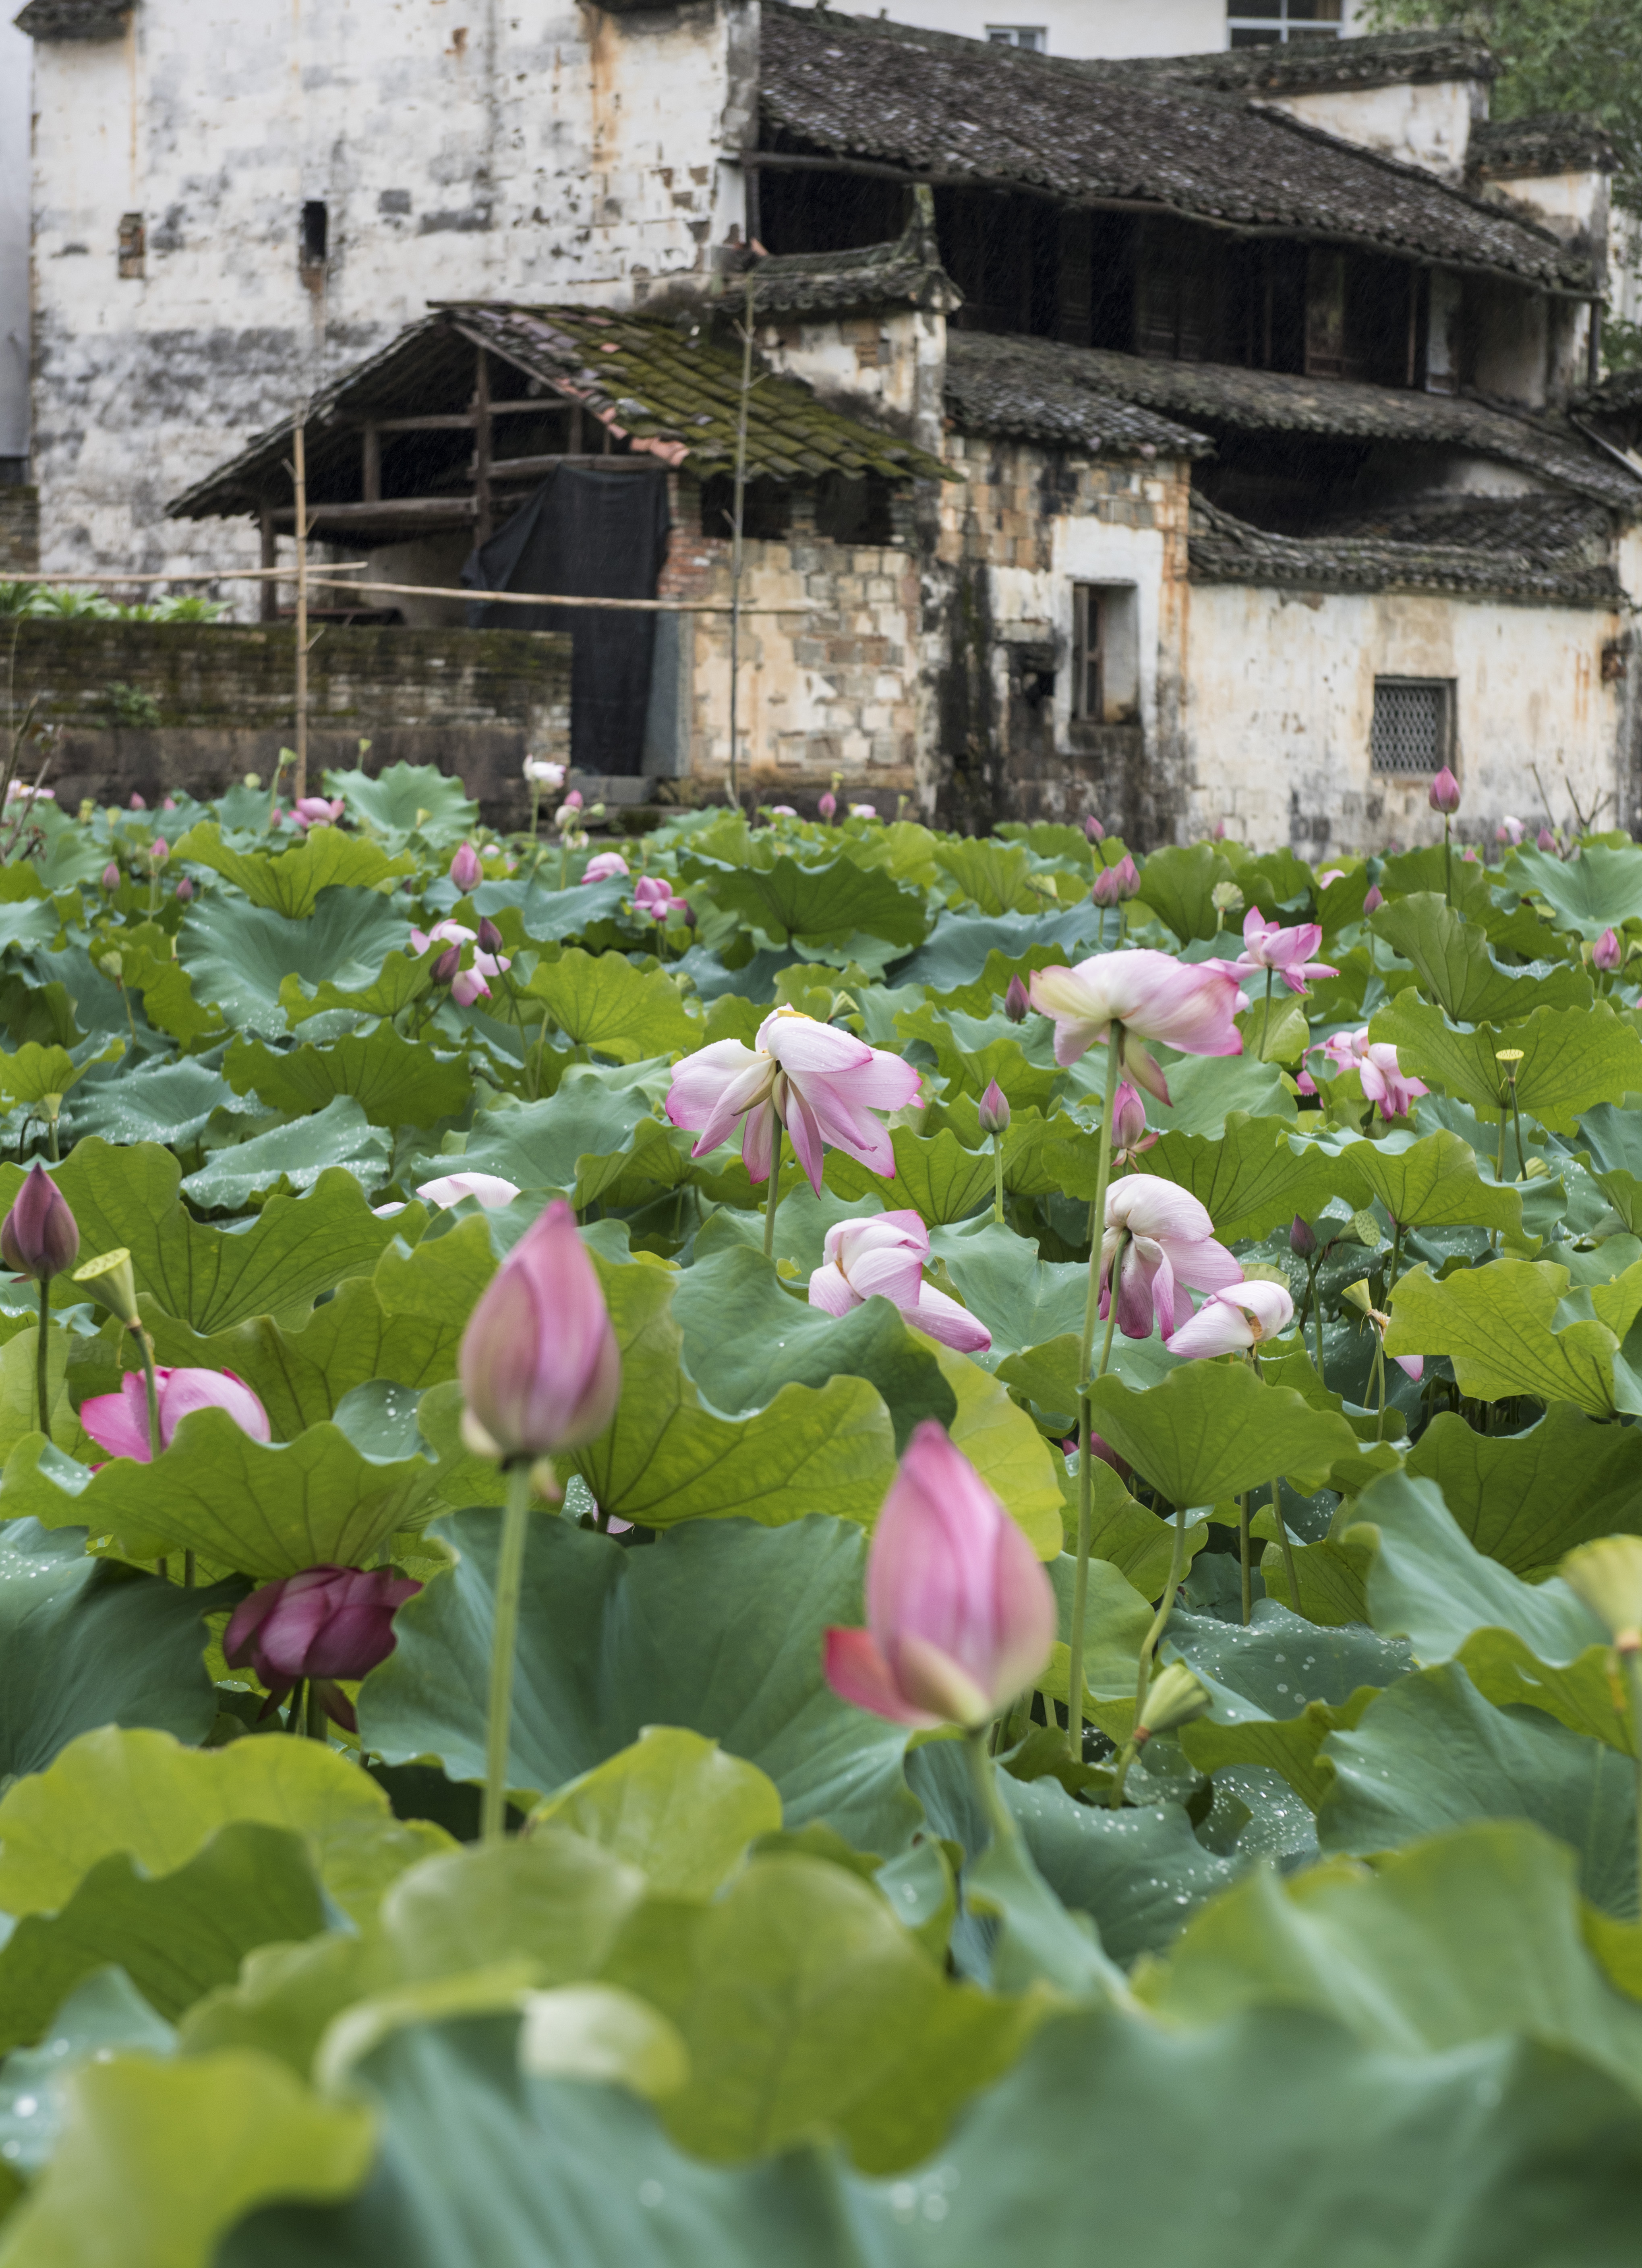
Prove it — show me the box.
[34,0,755,572]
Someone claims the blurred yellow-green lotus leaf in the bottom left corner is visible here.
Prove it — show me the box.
[0,2050,372,2268]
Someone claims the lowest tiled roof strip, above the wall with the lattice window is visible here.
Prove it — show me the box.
[1189,497,1626,608]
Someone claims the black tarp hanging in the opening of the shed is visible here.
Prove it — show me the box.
[463,465,669,773]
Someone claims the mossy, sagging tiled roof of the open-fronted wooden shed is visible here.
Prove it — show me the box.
[168,302,946,519]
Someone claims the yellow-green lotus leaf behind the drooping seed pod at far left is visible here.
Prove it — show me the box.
[0,1139,399,1331]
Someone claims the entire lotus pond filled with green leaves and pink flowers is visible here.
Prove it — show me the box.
[0,766,1642,2268]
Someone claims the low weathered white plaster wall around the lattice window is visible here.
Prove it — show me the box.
[1182,585,1626,860]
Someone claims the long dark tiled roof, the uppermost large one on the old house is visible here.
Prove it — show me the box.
[760,0,1594,290]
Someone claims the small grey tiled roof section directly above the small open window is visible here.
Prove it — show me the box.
[946,331,1213,456]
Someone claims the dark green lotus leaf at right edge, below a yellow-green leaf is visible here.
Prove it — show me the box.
[1406,1402,1642,1578]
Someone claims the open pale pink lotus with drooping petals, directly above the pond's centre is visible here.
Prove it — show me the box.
[667,1007,921,1195]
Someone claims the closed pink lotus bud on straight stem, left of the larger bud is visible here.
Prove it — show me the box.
[458,1197,621,1460]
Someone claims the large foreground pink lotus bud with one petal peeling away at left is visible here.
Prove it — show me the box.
[826,1417,1055,1730]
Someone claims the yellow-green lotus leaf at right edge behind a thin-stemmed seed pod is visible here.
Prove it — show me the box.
[1370,991,1642,1132]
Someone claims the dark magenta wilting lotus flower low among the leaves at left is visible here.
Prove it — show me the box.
[222,1567,422,1733]
